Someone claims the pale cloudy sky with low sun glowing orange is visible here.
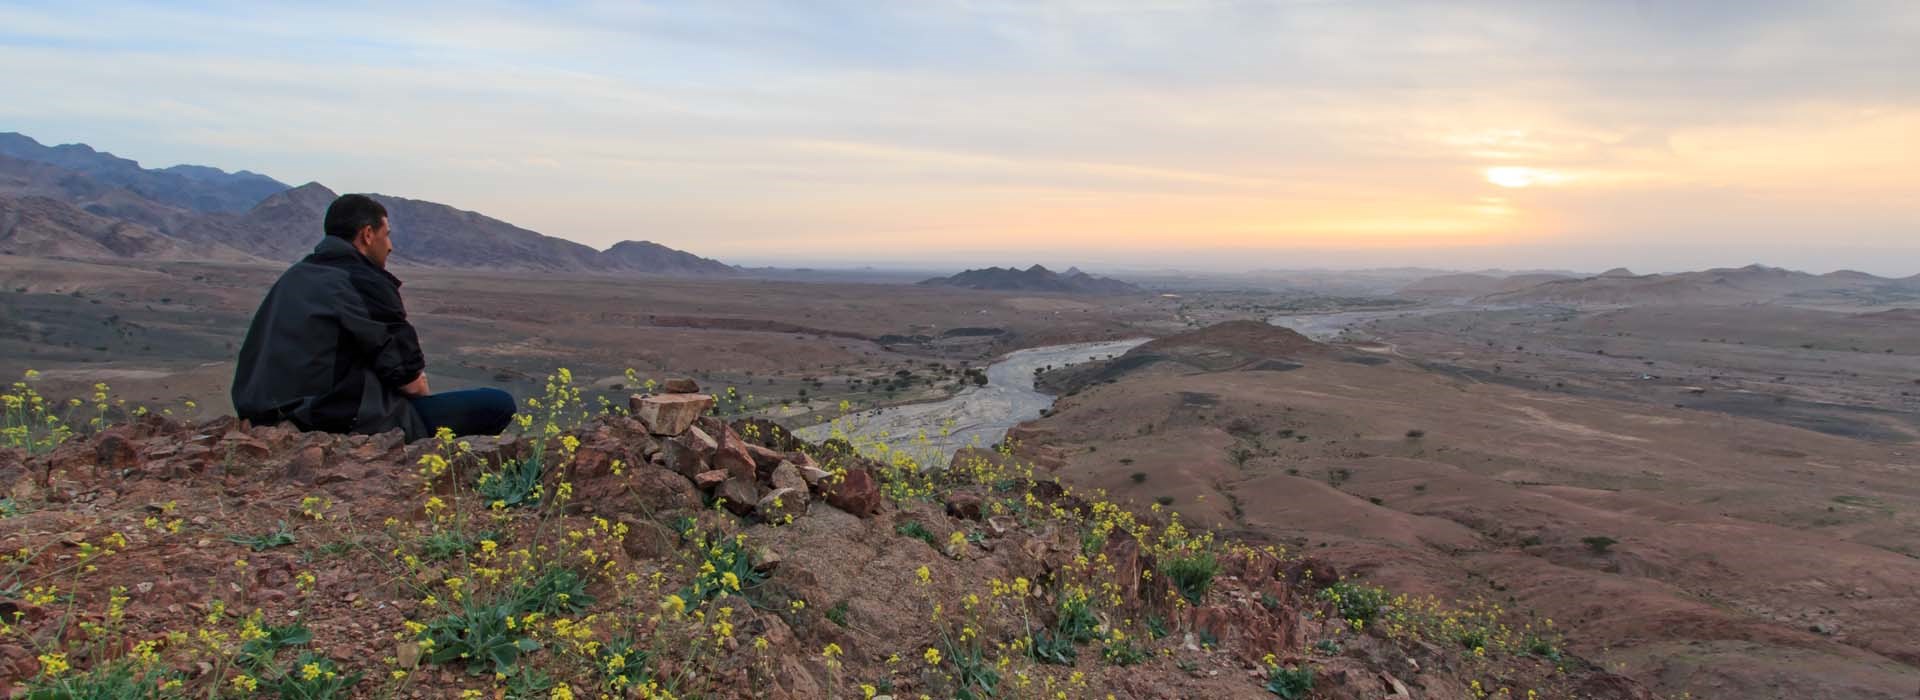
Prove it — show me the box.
[0,0,1920,276]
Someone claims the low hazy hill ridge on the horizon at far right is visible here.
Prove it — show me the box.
[1475,265,1920,305]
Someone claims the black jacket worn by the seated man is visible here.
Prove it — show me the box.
[232,236,428,441]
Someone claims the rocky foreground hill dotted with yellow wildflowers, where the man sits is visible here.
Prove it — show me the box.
[0,372,1649,700]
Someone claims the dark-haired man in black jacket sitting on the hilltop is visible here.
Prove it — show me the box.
[232,194,515,441]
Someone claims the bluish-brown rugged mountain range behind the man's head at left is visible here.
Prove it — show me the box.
[0,134,735,274]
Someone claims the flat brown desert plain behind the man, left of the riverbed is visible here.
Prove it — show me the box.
[0,255,1173,416]
